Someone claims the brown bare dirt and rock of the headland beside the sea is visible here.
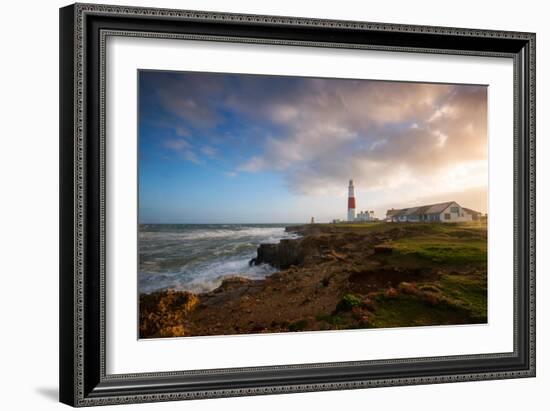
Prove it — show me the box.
[140,225,488,338]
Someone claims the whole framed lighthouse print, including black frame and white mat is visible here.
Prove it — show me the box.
[60,4,535,406]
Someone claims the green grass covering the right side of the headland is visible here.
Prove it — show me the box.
[318,222,487,329]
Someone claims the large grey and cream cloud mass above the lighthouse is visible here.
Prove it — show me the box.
[235,81,487,198]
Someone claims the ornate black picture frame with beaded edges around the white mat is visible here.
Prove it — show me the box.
[60,4,535,406]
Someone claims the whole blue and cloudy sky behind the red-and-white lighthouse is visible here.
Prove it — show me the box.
[138,71,488,224]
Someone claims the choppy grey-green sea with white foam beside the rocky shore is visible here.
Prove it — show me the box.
[138,224,297,294]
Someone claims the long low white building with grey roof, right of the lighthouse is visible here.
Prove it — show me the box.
[386,201,480,223]
